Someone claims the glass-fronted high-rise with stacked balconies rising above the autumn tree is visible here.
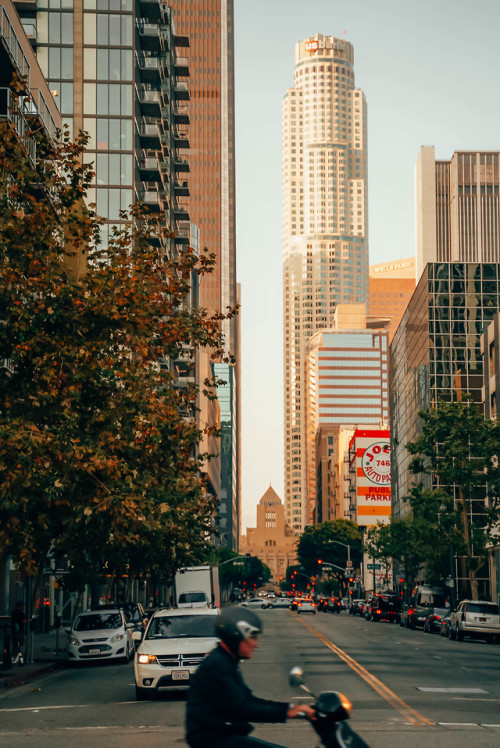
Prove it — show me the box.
[16,0,189,256]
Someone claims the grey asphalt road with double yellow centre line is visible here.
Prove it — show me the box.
[0,610,500,748]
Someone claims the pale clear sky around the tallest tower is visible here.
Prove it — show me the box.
[235,0,500,532]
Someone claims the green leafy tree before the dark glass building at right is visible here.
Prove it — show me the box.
[406,398,500,599]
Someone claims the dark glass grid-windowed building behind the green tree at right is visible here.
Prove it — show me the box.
[389,262,500,517]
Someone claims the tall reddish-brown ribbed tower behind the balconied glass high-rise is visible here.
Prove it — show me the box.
[169,0,240,550]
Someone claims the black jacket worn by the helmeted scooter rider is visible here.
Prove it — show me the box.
[186,645,288,748]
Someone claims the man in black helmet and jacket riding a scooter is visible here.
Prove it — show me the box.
[186,606,315,748]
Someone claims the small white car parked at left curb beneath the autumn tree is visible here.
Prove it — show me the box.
[66,608,134,662]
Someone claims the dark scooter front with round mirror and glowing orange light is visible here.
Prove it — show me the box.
[290,667,369,748]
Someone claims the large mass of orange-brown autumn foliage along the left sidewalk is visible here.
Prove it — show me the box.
[0,84,235,583]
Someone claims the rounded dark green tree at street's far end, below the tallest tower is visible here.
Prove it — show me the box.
[297,519,362,576]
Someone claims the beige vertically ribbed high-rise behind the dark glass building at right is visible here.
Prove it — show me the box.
[416,146,500,281]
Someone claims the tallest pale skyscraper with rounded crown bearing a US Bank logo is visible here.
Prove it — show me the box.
[282,34,368,534]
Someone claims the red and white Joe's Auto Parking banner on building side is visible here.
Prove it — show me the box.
[353,430,391,526]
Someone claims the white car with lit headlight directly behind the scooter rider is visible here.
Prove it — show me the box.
[133,608,219,701]
